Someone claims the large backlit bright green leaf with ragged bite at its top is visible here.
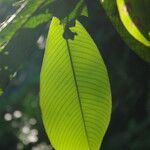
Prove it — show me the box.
[40,18,111,150]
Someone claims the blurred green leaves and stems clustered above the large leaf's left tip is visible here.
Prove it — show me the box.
[0,0,85,51]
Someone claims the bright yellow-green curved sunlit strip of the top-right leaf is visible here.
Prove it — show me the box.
[116,0,150,47]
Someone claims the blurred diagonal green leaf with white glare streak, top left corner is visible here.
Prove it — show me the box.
[0,0,52,51]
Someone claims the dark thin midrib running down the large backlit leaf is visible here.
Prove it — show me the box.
[66,39,91,150]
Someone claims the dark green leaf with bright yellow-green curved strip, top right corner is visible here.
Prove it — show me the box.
[100,0,150,63]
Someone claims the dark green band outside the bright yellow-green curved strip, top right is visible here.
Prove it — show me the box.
[100,0,150,63]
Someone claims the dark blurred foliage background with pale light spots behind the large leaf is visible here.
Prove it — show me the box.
[0,0,150,150]
